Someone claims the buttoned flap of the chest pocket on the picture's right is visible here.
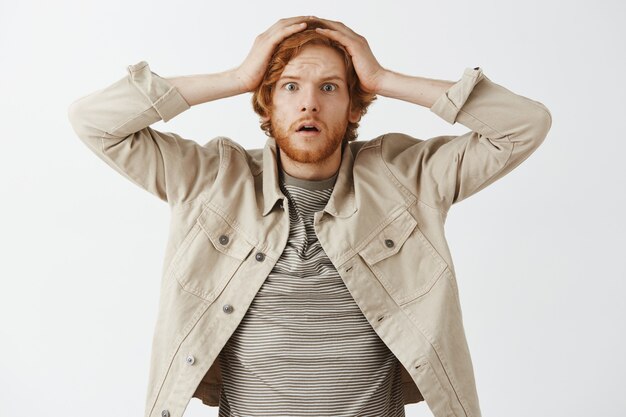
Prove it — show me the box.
[359,210,417,265]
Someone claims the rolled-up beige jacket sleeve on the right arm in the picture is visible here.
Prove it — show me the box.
[383,67,552,211]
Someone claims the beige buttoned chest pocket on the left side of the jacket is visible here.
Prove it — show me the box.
[173,208,254,301]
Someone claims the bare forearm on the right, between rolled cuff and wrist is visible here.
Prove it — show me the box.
[376,70,456,108]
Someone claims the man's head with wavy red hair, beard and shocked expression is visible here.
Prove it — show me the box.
[252,20,376,163]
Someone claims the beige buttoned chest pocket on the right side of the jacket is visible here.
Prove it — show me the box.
[359,210,447,305]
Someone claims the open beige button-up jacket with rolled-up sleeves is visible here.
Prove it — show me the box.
[68,61,552,417]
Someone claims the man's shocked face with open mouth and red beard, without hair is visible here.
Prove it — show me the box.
[271,45,358,164]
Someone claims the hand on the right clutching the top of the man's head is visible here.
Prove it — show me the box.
[315,17,387,94]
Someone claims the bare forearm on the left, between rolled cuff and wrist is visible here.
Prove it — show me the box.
[165,70,246,106]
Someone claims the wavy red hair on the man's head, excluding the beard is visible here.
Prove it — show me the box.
[252,19,376,141]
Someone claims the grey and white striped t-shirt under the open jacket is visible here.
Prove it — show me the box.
[218,167,404,417]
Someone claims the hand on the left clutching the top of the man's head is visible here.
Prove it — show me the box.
[235,16,310,92]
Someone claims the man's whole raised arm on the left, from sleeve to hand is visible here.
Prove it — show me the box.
[68,17,306,205]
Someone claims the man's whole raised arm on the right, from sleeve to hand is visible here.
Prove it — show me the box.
[318,20,552,212]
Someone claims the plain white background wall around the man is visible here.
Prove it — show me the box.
[0,0,626,417]
